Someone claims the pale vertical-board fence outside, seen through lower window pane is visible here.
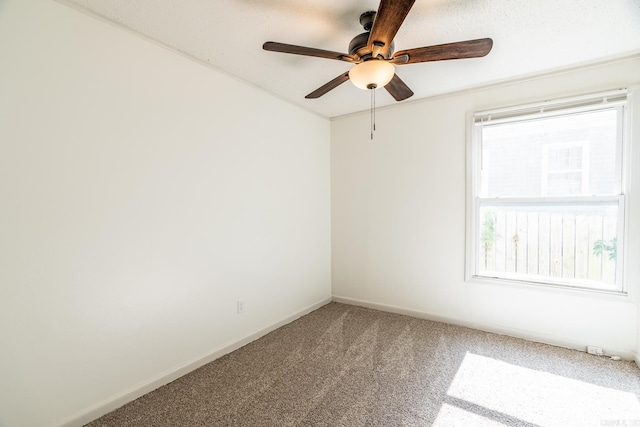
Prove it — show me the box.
[480,208,617,284]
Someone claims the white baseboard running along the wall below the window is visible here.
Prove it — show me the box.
[333,295,640,367]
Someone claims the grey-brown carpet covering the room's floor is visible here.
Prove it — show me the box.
[89,303,640,427]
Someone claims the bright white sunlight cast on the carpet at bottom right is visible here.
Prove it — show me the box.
[436,352,640,427]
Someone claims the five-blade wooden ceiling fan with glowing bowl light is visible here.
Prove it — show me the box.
[262,0,493,101]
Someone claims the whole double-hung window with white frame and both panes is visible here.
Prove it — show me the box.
[467,90,626,292]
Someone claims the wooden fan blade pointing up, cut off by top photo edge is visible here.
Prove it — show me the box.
[367,0,415,58]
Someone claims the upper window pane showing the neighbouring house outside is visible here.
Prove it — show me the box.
[480,108,620,197]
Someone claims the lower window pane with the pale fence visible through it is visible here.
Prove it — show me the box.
[477,201,619,289]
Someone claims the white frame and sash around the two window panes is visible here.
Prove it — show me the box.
[465,89,630,295]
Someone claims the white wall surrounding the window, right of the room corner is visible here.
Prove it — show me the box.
[331,57,640,357]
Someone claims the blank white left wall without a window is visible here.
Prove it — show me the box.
[0,0,331,427]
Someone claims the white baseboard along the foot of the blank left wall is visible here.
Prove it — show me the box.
[55,298,331,427]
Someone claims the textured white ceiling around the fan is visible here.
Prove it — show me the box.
[60,0,640,117]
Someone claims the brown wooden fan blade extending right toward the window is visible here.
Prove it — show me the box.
[393,38,493,65]
